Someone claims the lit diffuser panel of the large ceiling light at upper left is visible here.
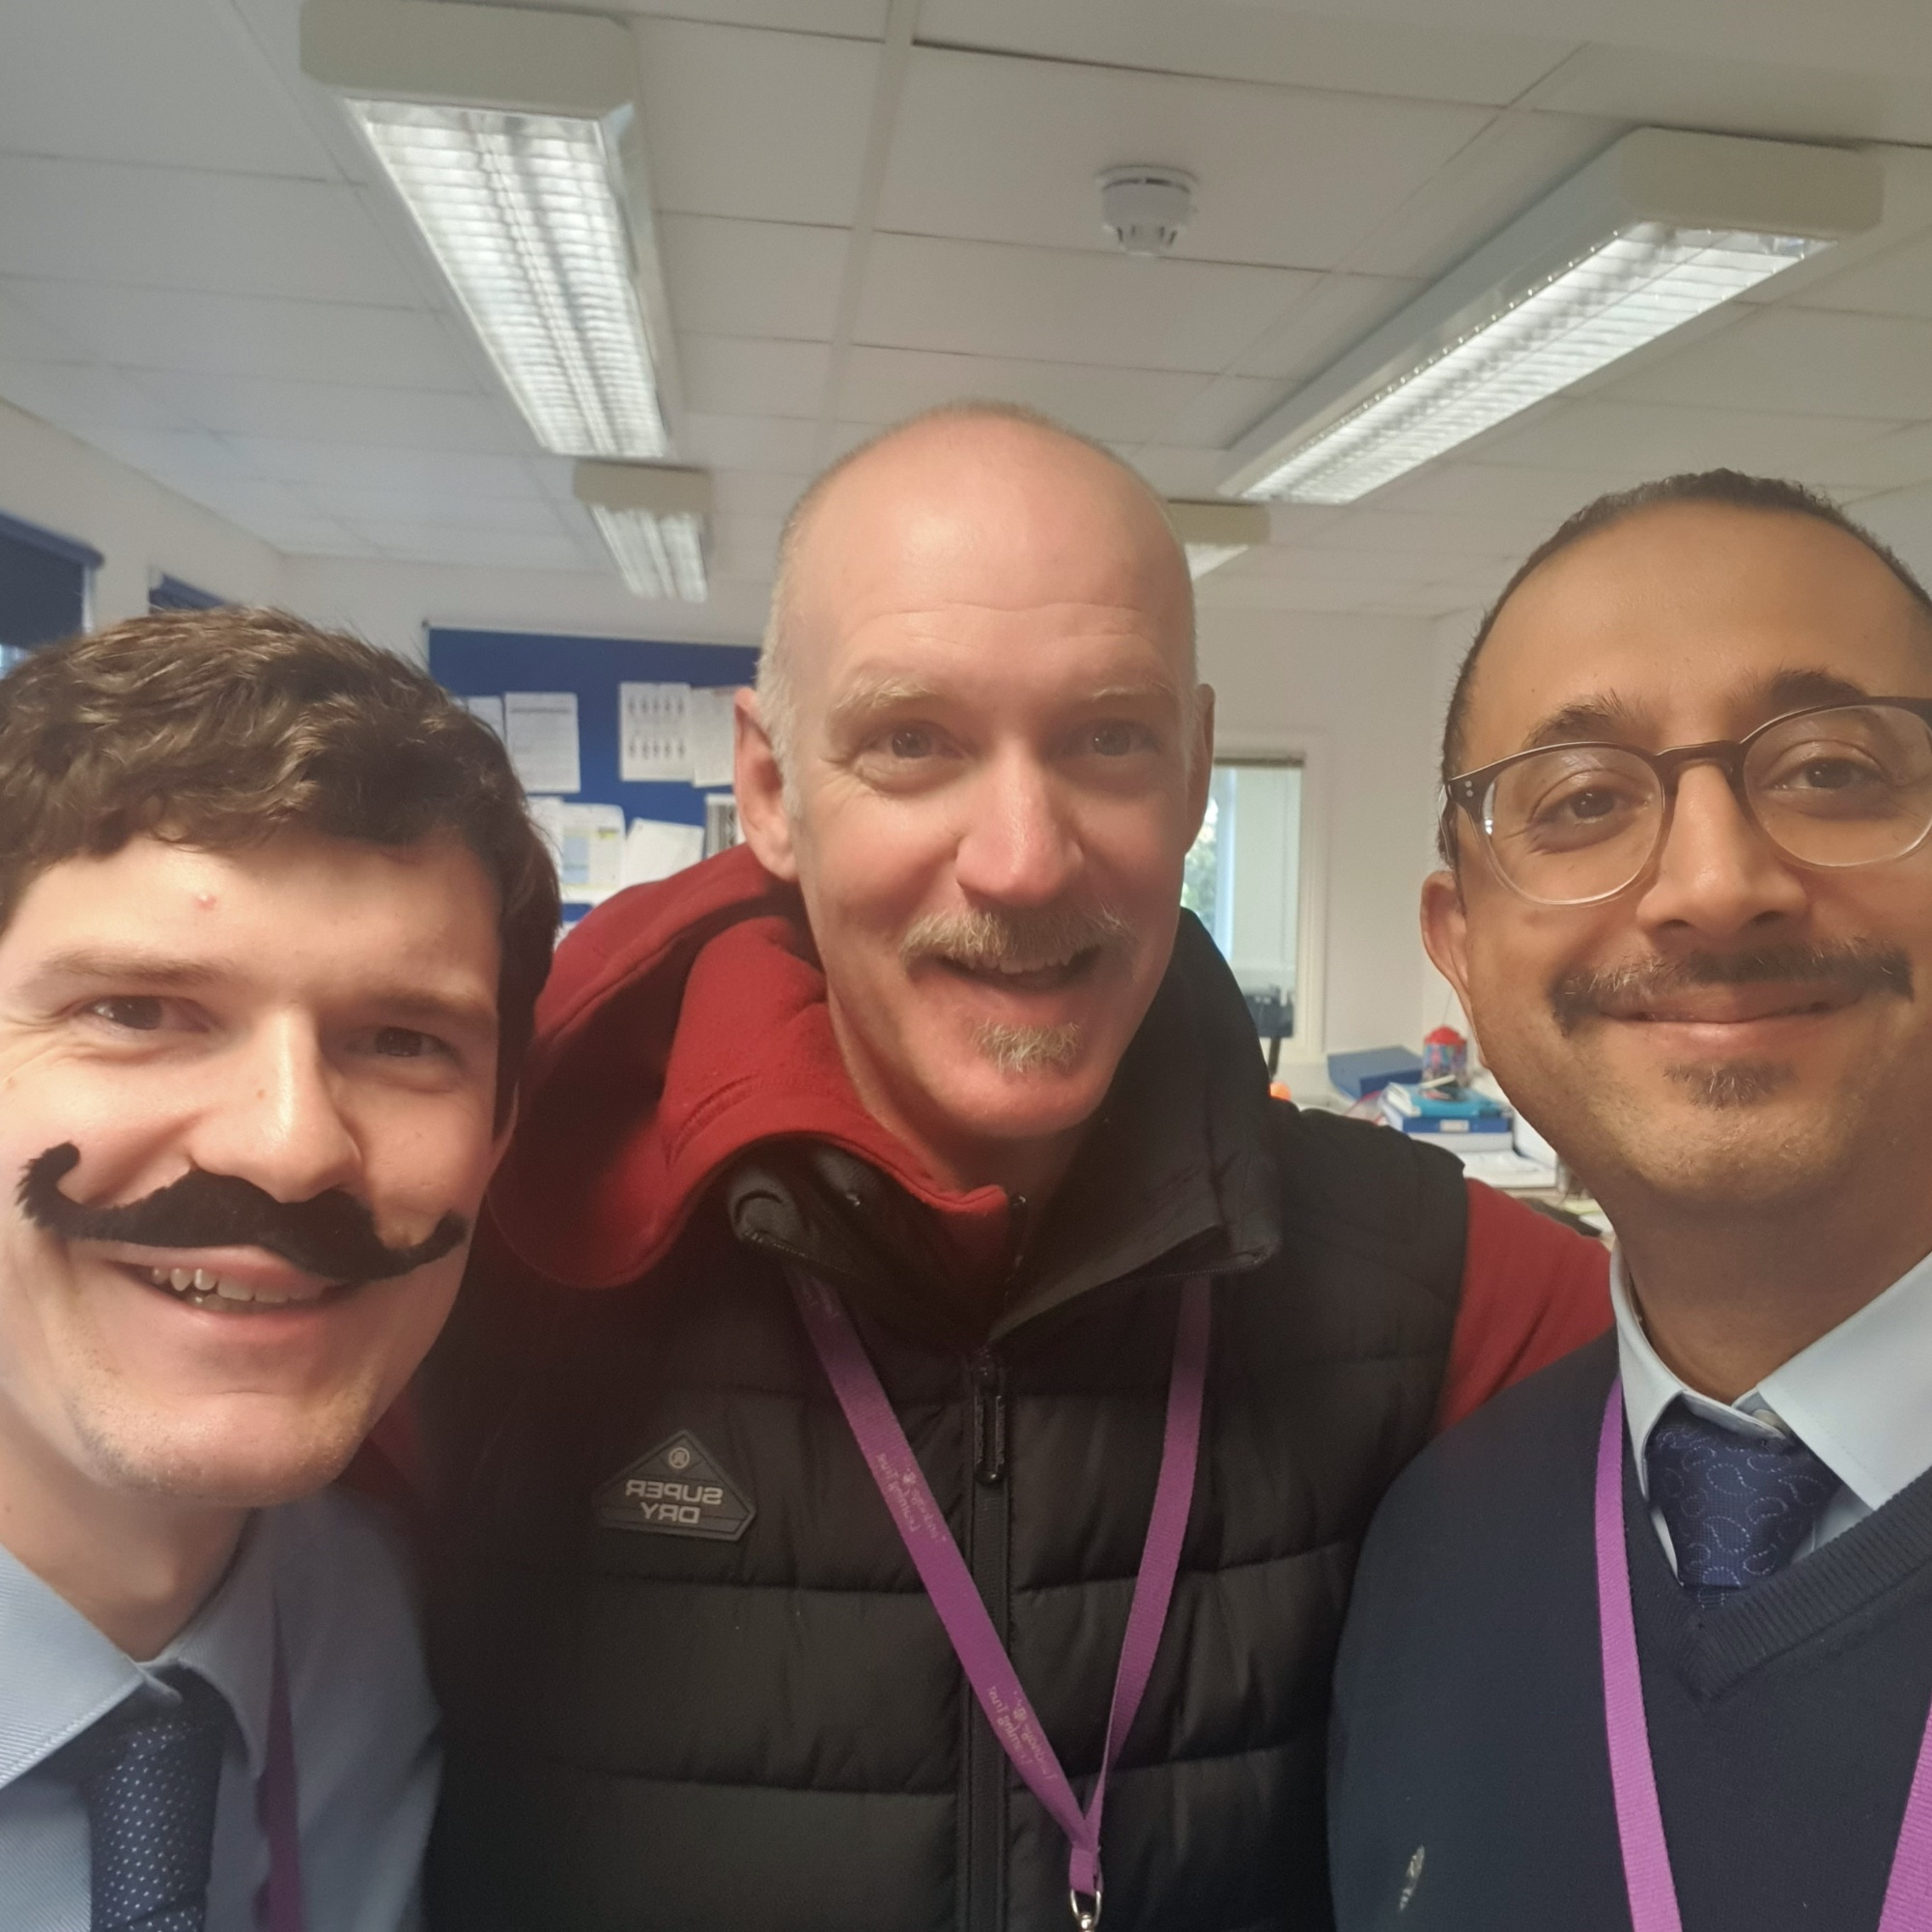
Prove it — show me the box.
[348,100,670,460]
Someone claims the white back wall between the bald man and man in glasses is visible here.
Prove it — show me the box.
[1202,607,1443,1084]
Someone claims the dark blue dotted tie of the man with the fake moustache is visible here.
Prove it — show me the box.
[68,1671,228,1932]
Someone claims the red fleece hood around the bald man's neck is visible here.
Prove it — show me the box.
[491,846,1009,1289]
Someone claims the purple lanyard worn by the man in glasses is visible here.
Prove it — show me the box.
[1596,1376,1932,1932]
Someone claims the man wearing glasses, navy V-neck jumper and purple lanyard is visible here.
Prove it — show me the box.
[1331,471,1932,1932]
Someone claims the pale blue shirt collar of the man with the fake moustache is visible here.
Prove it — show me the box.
[0,1515,274,1787]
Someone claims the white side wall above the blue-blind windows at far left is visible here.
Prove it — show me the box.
[0,402,286,624]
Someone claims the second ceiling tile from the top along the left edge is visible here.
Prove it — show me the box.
[0,155,419,307]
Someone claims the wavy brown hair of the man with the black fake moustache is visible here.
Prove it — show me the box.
[0,607,558,1124]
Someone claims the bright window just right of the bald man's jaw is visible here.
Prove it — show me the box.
[1180,759,1302,1053]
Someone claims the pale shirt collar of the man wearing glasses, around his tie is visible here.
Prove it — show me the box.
[1609,1252,1932,1569]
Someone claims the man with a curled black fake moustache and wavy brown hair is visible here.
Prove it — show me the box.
[0,611,556,1932]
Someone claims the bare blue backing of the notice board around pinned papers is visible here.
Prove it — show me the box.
[429,626,757,920]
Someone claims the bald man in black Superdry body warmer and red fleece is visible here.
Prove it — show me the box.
[431,406,1607,1932]
